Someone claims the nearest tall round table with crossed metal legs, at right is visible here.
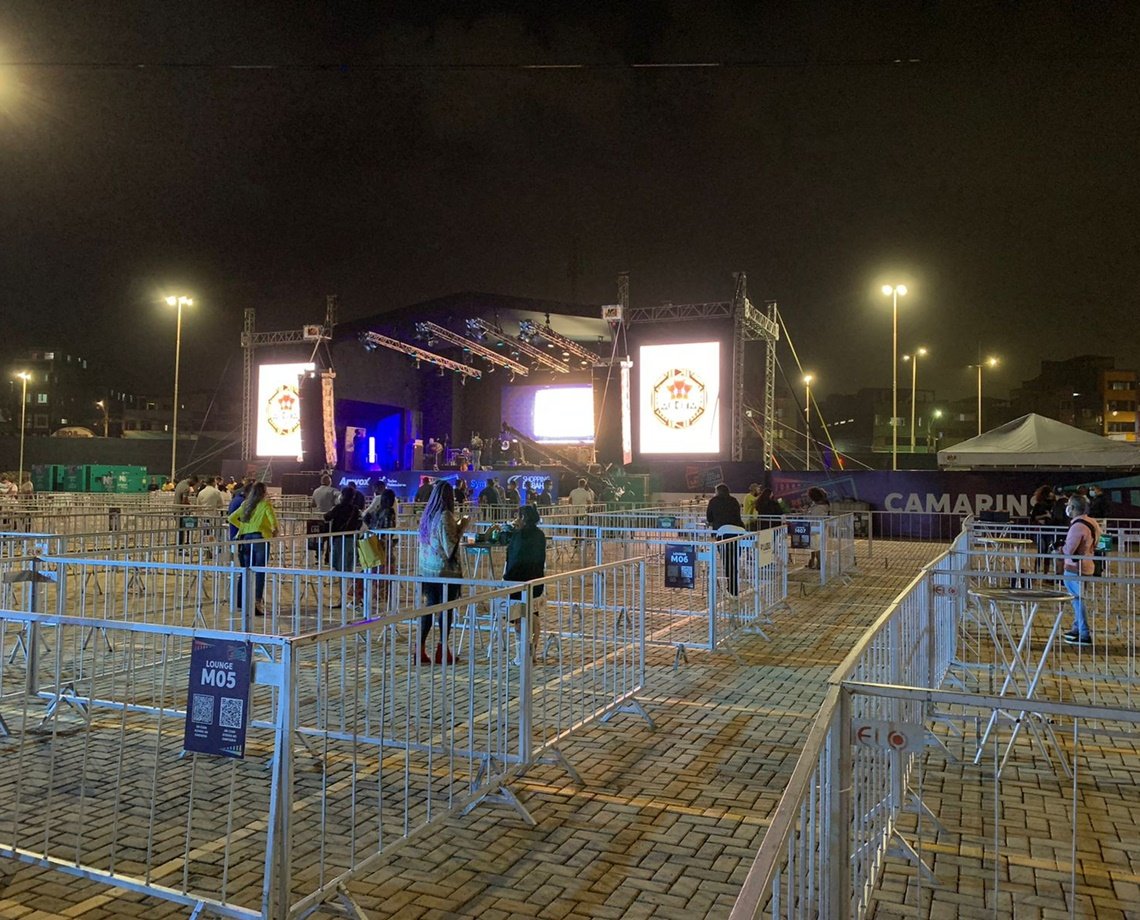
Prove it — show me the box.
[969,585,1073,779]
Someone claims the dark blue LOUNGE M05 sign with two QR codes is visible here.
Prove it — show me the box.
[182,638,253,757]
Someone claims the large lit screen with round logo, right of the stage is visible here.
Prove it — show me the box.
[637,342,720,455]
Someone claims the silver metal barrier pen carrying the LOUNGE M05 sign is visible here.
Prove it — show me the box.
[0,560,652,920]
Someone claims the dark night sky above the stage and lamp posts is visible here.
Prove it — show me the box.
[0,0,1140,396]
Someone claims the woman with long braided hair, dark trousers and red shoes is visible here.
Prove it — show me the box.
[418,479,467,665]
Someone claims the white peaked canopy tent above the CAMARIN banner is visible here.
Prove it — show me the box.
[938,413,1140,470]
